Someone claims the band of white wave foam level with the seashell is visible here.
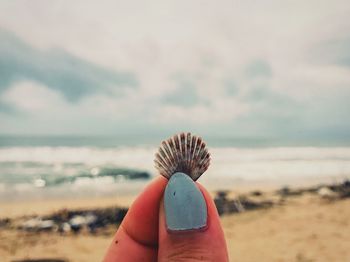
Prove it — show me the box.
[0,147,350,189]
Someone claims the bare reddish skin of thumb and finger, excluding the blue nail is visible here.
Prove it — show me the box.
[104,177,228,262]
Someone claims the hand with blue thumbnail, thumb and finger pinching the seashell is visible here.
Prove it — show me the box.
[104,177,228,262]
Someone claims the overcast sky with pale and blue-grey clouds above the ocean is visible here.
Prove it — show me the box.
[0,0,350,143]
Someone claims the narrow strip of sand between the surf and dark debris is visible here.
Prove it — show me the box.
[0,176,347,218]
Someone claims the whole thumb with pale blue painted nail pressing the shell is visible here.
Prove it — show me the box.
[158,173,228,262]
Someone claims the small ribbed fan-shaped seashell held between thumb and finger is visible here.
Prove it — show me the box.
[154,133,210,181]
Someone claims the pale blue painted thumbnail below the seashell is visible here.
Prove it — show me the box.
[164,172,207,232]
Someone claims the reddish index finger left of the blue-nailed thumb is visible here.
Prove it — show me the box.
[104,176,167,261]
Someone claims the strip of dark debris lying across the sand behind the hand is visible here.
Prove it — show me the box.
[4,180,350,234]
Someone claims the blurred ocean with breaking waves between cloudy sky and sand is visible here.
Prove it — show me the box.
[0,137,350,201]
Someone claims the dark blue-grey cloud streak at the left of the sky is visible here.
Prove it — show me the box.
[0,30,138,102]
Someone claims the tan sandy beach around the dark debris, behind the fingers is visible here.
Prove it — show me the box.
[0,184,350,262]
